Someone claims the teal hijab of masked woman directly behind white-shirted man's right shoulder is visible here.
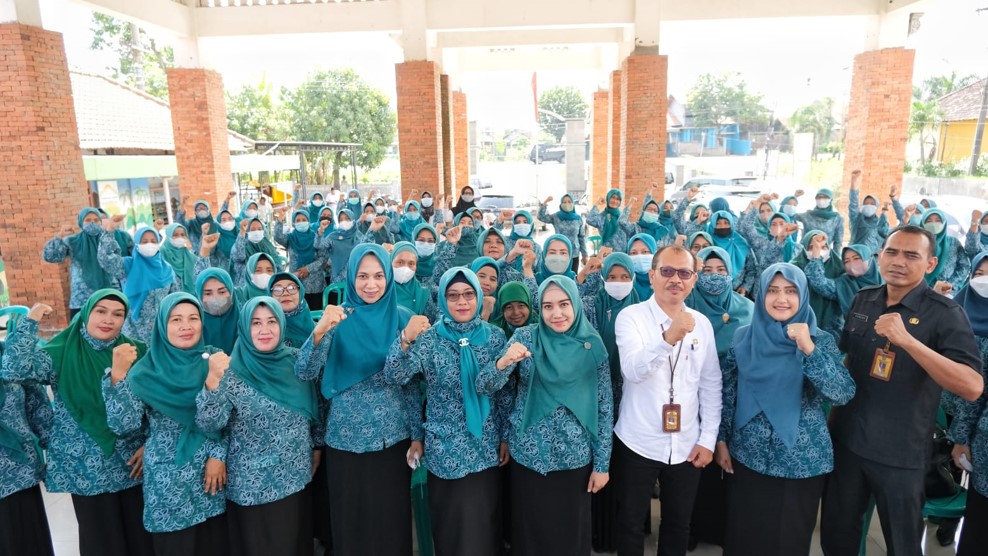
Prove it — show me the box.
[686,247,754,360]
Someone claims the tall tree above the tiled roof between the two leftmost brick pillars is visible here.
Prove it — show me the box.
[89,12,175,99]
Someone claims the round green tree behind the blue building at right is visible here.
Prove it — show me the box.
[686,73,771,131]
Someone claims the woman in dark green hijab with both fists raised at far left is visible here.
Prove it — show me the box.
[2,289,154,556]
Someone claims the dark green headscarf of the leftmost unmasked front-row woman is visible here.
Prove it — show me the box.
[42,288,147,456]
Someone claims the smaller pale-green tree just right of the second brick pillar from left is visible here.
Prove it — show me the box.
[226,77,290,141]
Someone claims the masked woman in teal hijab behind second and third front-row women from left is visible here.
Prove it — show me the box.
[196,268,240,353]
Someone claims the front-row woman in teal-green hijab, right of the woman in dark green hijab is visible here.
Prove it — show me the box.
[103,292,230,556]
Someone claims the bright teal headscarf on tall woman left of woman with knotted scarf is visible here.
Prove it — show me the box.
[322,243,412,399]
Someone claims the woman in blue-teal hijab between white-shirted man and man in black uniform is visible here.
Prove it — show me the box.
[715,263,855,555]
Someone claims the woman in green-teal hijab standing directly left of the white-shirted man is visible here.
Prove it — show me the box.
[477,275,614,556]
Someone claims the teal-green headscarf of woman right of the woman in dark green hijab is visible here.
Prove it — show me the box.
[127,292,221,466]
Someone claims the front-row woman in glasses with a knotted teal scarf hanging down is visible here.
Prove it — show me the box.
[387,267,512,556]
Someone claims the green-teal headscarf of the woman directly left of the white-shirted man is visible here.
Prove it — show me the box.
[521,276,607,438]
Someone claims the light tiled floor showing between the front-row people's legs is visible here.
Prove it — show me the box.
[42,489,954,556]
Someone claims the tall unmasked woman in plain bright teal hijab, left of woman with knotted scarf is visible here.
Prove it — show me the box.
[295,243,418,554]
